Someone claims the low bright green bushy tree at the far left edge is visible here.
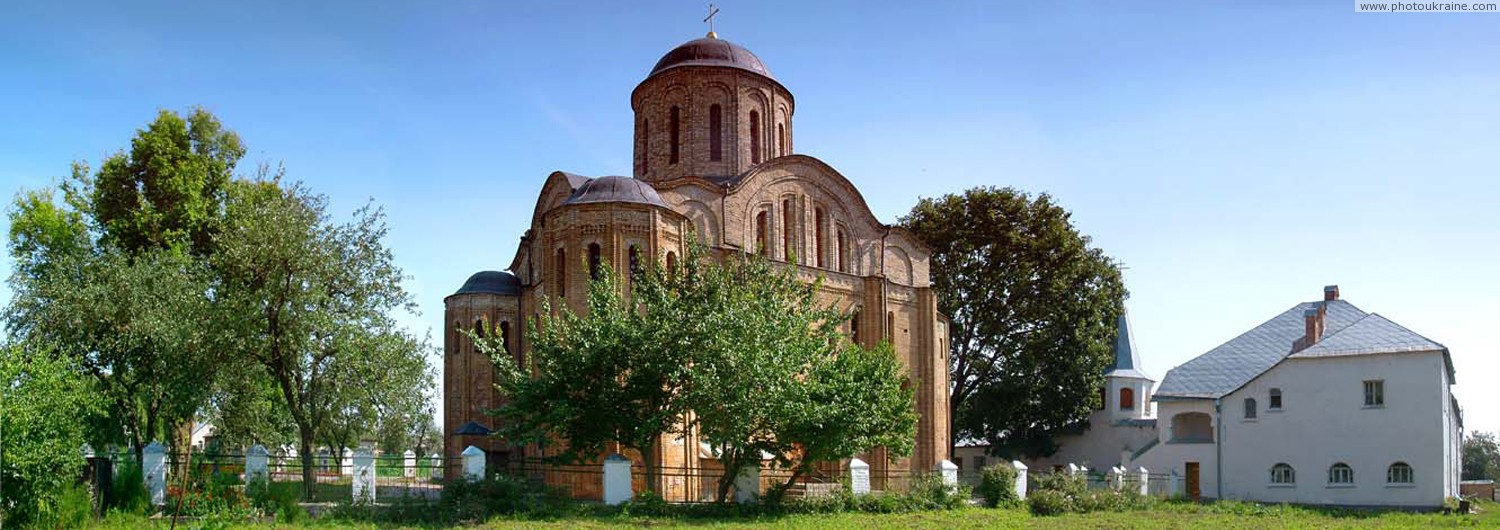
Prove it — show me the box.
[0,344,99,527]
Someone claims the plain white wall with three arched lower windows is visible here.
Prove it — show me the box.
[1218,353,1452,506]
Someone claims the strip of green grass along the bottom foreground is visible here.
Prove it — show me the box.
[85,503,1500,530]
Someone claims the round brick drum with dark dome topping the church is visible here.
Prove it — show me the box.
[630,32,795,182]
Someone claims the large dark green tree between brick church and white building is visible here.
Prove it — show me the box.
[902,188,1127,455]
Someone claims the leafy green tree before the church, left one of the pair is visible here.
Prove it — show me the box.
[489,263,695,491]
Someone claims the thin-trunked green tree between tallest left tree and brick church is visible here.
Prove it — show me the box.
[212,174,431,495]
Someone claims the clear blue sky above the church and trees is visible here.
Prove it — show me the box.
[0,0,1500,431]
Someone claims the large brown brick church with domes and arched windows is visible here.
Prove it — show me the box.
[443,33,950,500]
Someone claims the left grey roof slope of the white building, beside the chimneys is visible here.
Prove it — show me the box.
[1155,300,1367,399]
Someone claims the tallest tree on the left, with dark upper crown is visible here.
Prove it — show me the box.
[8,108,245,452]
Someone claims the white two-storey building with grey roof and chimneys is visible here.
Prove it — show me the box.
[1128,285,1463,506]
